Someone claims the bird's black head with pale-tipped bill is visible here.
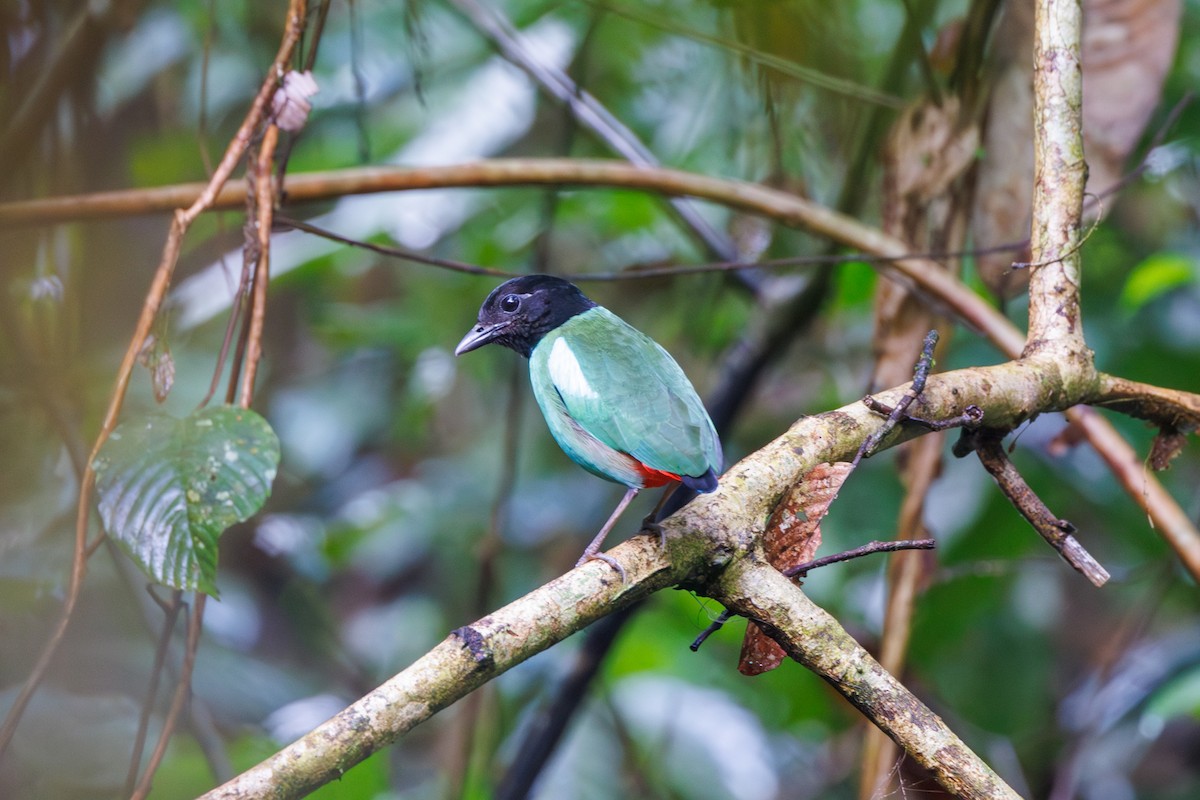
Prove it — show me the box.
[454,275,595,359]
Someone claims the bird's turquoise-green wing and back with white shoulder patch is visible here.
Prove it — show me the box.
[530,307,721,476]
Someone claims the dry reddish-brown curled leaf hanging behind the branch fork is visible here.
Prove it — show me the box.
[738,462,850,675]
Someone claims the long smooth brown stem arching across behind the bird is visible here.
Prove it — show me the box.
[0,158,1200,581]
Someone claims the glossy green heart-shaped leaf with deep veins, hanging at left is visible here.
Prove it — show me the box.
[95,405,280,595]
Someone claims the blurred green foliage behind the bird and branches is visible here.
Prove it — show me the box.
[0,0,1200,800]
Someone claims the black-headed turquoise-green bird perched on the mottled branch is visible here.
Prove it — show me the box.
[455,275,722,582]
